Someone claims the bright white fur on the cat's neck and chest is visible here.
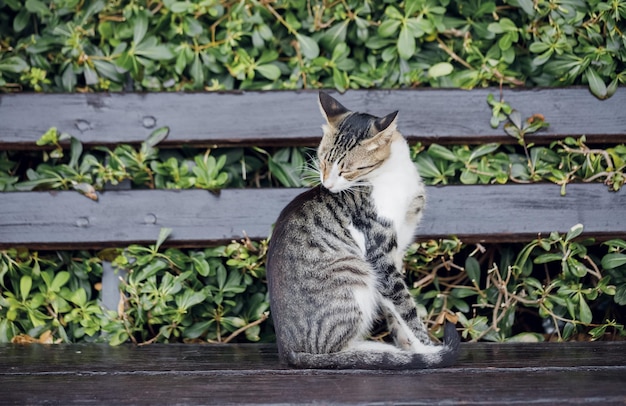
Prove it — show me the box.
[369,138,424,252]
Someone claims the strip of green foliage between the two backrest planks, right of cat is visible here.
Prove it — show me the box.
[412,137,626,194]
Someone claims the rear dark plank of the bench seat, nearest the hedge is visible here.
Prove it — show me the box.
[0,341,626,376]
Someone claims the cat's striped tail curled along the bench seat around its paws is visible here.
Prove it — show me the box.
[284,323,461,369]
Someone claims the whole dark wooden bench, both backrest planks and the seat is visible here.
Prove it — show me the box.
[0,88,626,404]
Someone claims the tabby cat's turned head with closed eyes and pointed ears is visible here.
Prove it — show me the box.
[317,92,400,193]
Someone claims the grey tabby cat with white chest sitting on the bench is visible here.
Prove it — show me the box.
[267,92,460,369]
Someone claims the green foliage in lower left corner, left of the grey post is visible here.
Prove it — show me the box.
[0,249,102,342]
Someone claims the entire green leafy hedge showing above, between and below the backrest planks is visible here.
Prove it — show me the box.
[0,0,626,344]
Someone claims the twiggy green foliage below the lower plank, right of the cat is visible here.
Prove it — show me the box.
[407,224,626,341]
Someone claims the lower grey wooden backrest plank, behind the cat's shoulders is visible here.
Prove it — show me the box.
[0,184,626,249]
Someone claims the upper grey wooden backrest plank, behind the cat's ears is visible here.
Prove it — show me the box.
[0,88,626,149]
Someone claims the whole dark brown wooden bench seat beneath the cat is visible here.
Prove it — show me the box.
[0,342,626,405]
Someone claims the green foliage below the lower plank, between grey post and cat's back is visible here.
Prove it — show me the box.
[102,230,269,344]
